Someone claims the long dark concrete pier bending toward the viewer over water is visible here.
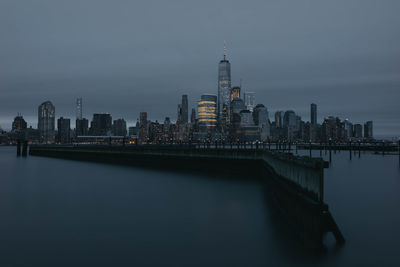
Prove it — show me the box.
[29,145,344,248]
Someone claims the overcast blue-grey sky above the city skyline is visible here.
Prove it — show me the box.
[0,0,400,136]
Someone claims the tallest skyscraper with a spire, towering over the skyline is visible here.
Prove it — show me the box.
[217,45,231,118]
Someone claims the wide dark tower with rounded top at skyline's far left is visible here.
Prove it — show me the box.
[38,101,56,143]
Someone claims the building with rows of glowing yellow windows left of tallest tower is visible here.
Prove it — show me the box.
[197,94,217,132]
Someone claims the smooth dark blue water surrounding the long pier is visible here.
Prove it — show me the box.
[0,147,400,266]
